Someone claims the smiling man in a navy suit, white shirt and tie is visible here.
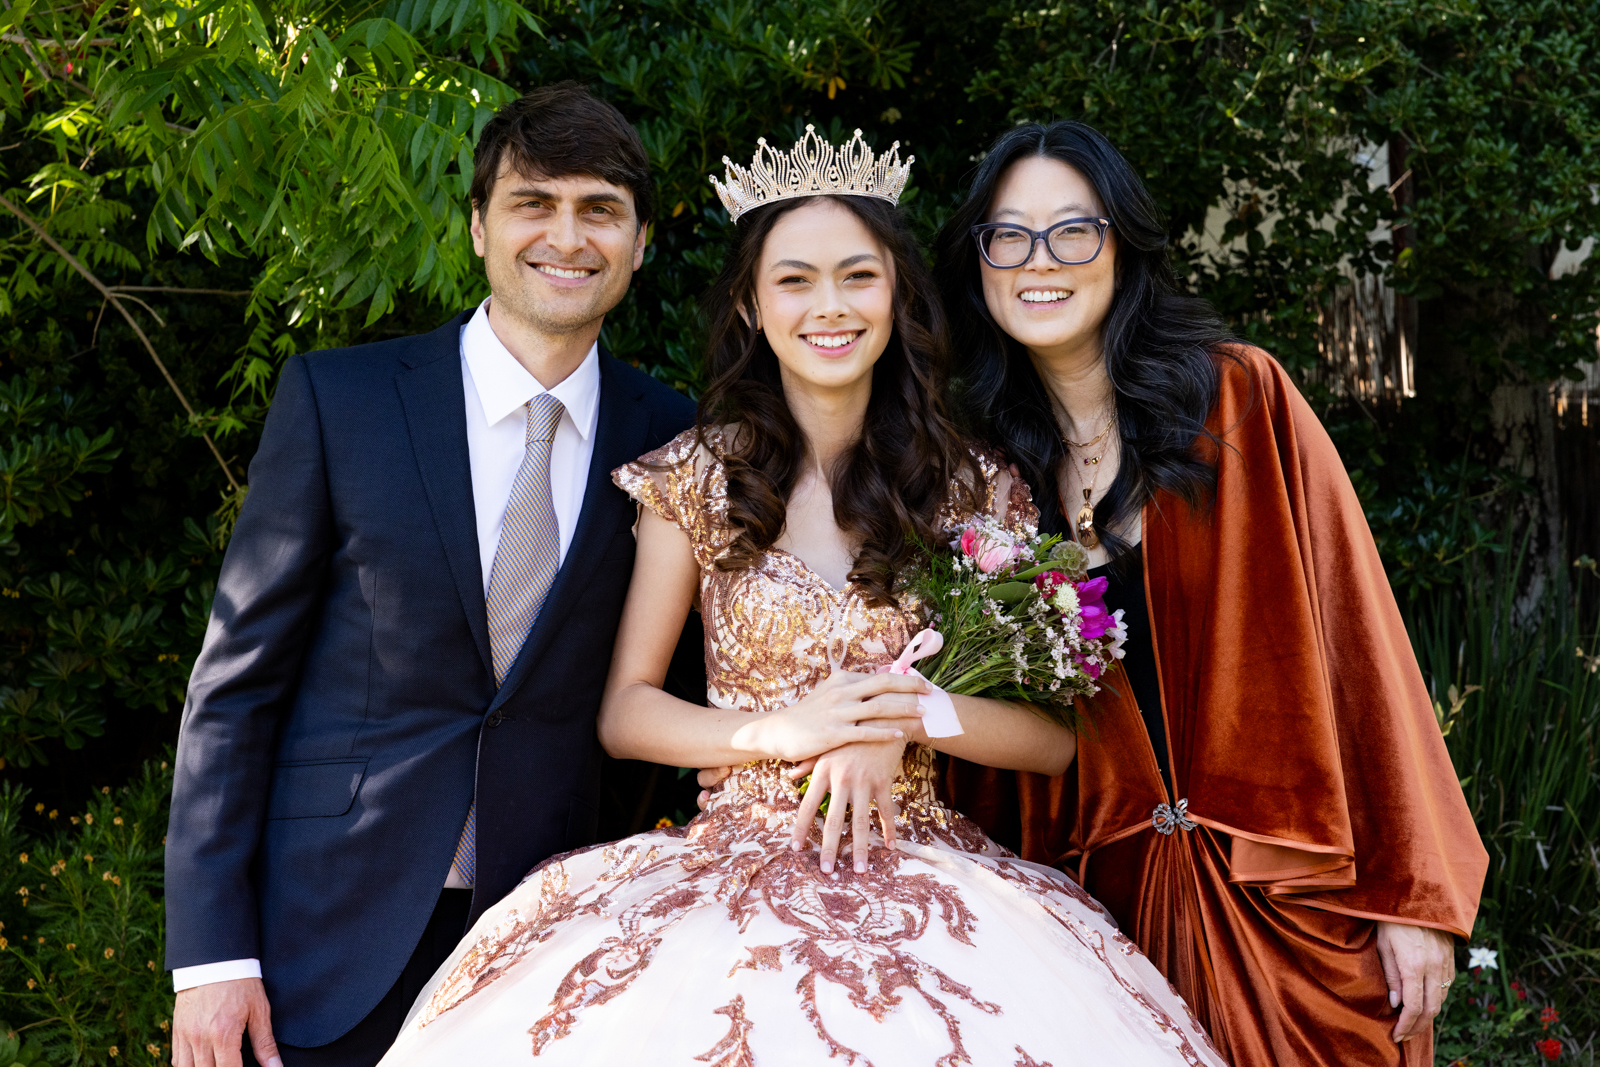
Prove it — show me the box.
[166,83,693,1067]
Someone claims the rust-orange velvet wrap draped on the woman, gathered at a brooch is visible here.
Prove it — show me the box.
[947,349,1488,1067]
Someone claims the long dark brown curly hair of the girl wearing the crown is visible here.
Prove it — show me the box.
[696,197,982,606]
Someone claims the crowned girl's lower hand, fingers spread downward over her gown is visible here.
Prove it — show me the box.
[789,737,906,873]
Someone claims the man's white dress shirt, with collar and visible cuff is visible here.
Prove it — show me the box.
[173,301,600,992]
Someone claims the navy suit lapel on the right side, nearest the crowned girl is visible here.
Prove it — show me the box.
[492,349,650,710]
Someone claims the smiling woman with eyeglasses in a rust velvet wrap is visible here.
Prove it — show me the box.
[938,122,1486,1067]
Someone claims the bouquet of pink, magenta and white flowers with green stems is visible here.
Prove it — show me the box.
[890,520,1128,736]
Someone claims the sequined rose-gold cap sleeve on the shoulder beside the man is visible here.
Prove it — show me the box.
[611,427,728,566]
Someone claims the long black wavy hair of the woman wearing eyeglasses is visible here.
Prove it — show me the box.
[934,122,1232,558]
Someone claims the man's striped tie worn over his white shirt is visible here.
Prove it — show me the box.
[453,394,563,888]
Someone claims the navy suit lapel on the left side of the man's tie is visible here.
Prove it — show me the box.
[395,312,494,677]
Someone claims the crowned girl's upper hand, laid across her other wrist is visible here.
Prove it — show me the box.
[733,670,931,763]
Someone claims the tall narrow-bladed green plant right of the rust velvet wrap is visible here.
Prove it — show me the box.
[1411,543,1600,952]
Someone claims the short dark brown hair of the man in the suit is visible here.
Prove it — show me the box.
[472,82,656,226]
